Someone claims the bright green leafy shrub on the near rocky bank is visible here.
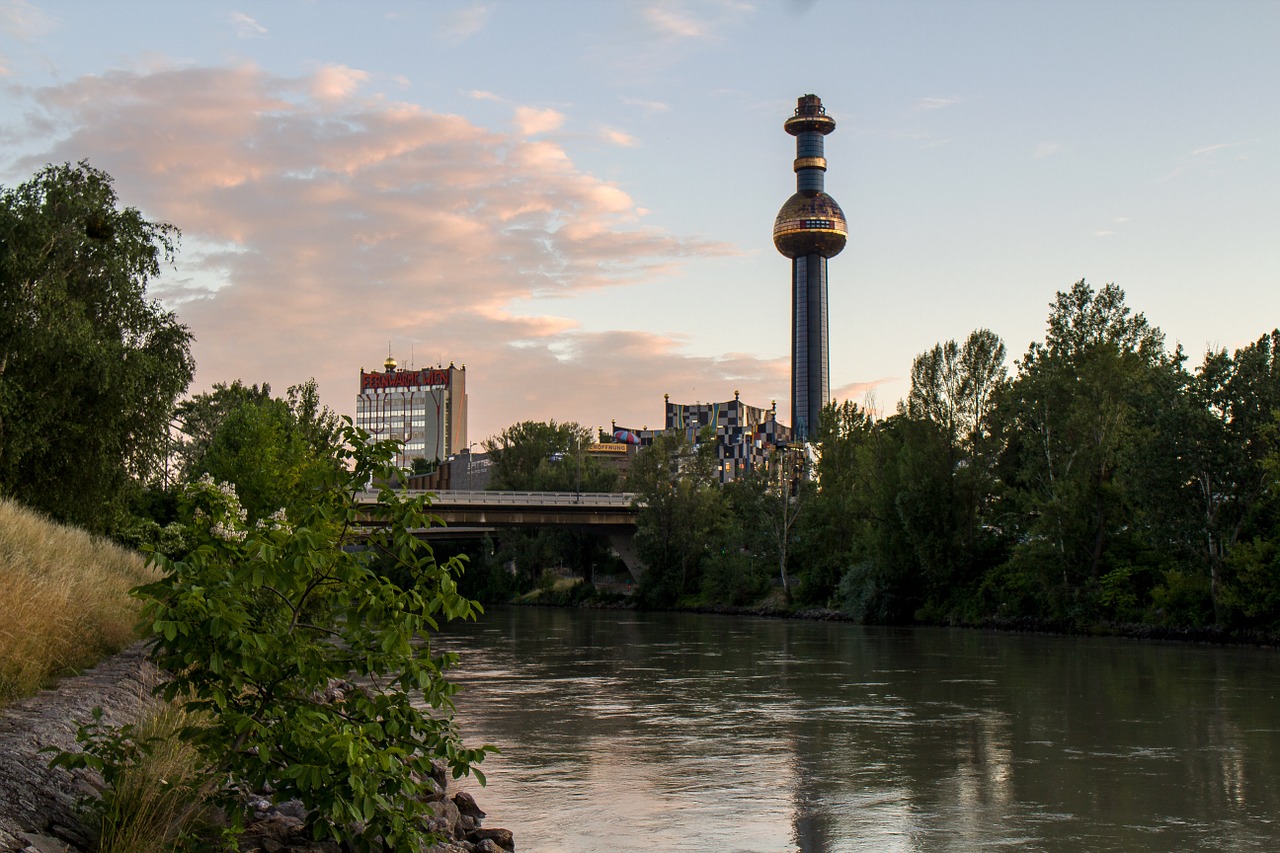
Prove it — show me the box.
[137,420,490,850]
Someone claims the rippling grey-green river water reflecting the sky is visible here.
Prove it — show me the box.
[440,607,1280,853]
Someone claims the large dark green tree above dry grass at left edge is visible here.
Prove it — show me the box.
[0,161,195,530]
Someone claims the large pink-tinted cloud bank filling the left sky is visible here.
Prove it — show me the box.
[5,65,742,438]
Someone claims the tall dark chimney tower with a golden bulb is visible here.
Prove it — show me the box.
[773,95,849,442]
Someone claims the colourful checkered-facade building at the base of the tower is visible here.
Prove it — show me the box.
[613,391,791,483]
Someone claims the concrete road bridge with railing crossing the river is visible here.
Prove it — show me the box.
[357,489,644,580]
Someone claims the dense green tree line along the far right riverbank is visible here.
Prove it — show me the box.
[631,280,1280,633]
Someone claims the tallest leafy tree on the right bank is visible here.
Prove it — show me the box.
[1002,280,1180,617]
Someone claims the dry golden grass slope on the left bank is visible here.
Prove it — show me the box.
[0,500,156,704]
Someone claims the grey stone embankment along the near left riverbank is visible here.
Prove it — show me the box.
[0,644,515,853]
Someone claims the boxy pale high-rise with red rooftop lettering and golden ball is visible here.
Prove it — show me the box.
[356,356,467,467]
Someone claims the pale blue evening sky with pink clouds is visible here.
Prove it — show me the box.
[0,0,1280,442]
